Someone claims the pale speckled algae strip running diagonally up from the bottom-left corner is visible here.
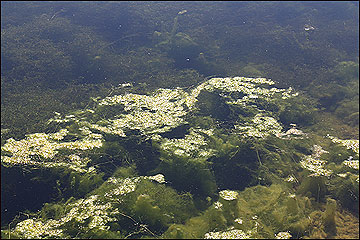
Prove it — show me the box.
[12,174,165,239]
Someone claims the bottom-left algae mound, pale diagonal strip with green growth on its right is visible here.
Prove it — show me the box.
[2,174,197,238]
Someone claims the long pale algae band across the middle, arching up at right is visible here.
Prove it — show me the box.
[33,77,298,145]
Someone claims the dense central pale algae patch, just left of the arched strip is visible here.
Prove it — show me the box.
[97,89,188,136]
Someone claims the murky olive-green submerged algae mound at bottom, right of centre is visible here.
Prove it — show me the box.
[164,185,312,238]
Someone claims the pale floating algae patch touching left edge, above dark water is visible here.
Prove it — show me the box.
[1,129,102,172]
